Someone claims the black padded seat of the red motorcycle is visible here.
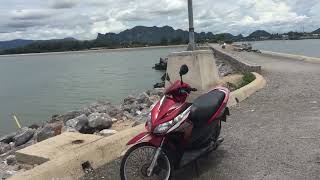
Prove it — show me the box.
[189,89,226,127]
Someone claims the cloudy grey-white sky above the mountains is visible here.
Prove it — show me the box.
[0,0,320,41]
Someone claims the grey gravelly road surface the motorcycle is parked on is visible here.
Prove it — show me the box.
[83,50,320,180]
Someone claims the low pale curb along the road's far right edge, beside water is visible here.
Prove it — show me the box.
[261,51,320,63]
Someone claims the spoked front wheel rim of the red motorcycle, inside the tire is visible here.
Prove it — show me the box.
[123,146,171,180]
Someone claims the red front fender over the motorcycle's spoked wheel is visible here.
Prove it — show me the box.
[127,132,163,147]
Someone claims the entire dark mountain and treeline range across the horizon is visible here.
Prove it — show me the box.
[0,26,320,54]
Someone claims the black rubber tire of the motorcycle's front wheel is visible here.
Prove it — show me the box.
[120,143,174,180]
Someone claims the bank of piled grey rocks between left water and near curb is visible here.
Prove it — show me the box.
[0,89,163,179]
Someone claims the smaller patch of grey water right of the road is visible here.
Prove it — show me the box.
[250,39,320,57]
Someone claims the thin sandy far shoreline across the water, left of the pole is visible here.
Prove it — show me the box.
[0,45,187,58]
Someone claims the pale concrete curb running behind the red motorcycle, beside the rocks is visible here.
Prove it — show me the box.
[9,73,266,180]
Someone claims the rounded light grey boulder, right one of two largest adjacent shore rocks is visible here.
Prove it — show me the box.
[88,113,112,130]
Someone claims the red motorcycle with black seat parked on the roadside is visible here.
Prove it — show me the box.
[120,65,230,180]
